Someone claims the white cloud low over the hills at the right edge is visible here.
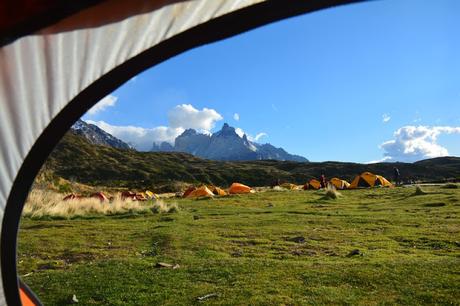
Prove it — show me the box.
[380,126,460,162]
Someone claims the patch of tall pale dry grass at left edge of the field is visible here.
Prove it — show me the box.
[22,190,178,219]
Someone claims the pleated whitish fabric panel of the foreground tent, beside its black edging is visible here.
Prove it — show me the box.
[0,0,262,305]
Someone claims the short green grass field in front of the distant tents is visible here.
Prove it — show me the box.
[18,187,460,305]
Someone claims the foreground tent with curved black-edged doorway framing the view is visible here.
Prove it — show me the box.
[0,0,366,305]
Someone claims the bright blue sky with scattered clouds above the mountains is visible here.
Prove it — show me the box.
[83,0,460,162]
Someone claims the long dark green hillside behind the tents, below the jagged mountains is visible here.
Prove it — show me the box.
[44,131,460,189]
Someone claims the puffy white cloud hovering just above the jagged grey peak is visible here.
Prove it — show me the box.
[168,104,223,132]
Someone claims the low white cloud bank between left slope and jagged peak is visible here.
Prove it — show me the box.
[87,120,184,151]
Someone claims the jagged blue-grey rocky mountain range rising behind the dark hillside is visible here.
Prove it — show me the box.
[151,123,308,162]
